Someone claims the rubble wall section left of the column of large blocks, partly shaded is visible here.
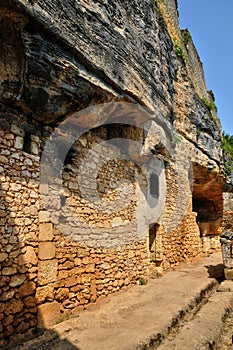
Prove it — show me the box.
[0,124,40,342]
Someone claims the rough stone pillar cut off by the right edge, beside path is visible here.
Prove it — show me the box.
[220,231,233,280]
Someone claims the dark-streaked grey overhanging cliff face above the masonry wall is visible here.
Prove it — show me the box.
[1,0,224,162]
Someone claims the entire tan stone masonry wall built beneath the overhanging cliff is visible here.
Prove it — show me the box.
[0,118,222,348]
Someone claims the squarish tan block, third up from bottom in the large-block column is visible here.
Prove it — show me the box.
[38,259,58,286]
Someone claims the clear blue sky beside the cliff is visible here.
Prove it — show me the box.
[178,0,233,135]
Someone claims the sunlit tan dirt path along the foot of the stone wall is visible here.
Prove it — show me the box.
[12,253,233,350]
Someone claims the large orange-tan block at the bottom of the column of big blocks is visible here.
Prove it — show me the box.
[38,301,60,328]
